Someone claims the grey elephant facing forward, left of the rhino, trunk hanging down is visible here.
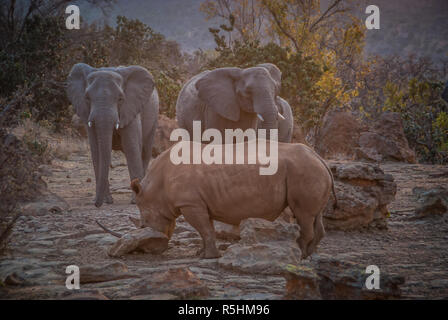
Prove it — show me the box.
[67,63,159,207]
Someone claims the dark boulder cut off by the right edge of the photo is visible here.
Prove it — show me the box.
[412,186,448,218]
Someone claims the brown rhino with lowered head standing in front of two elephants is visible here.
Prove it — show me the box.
[123,141,337,258]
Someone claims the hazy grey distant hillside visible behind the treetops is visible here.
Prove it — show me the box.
[80,0,448,60]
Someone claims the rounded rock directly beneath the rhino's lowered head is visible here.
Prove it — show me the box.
[108,227,169,257]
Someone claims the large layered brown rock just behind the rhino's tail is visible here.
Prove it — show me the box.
[324,162,397,230]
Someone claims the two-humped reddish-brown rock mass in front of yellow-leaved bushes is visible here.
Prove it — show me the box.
[314,111,415,163]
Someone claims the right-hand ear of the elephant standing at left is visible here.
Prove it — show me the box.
[116,66,154,128]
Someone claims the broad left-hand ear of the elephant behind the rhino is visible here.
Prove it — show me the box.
[196,68,242,121]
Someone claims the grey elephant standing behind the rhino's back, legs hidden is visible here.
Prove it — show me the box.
[176,64,288,137]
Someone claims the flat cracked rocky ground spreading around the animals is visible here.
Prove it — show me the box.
[0,142,448,299]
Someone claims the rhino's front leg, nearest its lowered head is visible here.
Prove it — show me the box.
[180,207,221,259]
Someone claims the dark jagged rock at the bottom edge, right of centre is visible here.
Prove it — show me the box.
[284,255,405,300]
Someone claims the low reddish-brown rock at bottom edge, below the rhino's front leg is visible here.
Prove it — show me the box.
[132,268,209,299]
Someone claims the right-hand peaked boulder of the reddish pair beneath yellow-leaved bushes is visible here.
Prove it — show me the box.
[358,112,415,163]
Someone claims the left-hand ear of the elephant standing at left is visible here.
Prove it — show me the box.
[67,63,96,123]
